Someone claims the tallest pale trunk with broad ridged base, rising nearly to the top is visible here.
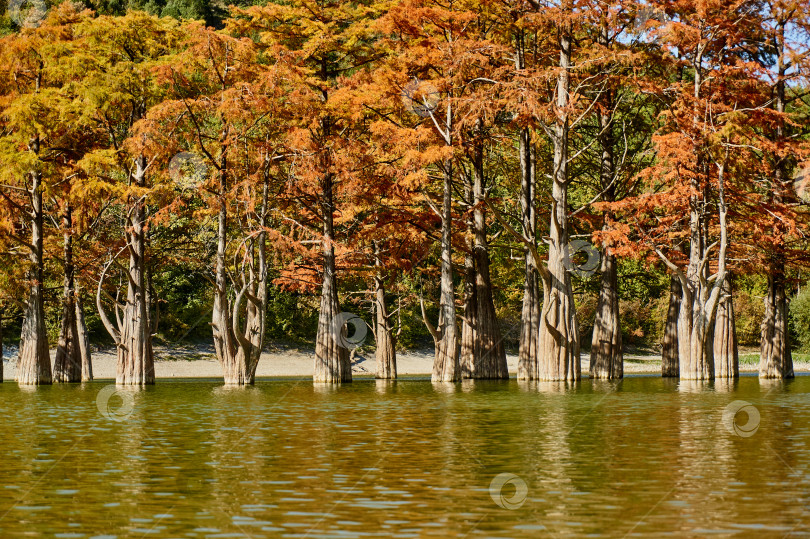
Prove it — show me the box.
[539,23,580,381]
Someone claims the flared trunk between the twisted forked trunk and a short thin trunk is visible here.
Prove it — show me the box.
[313,173,352,383]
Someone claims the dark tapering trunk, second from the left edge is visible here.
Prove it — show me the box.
[53,203,82,382]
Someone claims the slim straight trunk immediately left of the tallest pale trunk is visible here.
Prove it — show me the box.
[517,128,540,380]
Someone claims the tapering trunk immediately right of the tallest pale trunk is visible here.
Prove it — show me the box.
[589,252,624,380]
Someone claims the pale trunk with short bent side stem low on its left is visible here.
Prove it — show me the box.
[430,162,461,382]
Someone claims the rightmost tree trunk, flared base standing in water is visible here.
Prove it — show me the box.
[759,272,793,378]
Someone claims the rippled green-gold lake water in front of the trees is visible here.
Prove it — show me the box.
[0,377,810,538]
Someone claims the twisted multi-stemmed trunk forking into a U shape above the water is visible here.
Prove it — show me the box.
[212,154,268,386]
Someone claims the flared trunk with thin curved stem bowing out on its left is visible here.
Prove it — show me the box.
[96,155,155,386]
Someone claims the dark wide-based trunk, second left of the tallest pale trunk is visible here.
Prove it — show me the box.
[461,132,509,380]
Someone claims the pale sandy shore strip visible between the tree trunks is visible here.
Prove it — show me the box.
[3,345,810,380]
